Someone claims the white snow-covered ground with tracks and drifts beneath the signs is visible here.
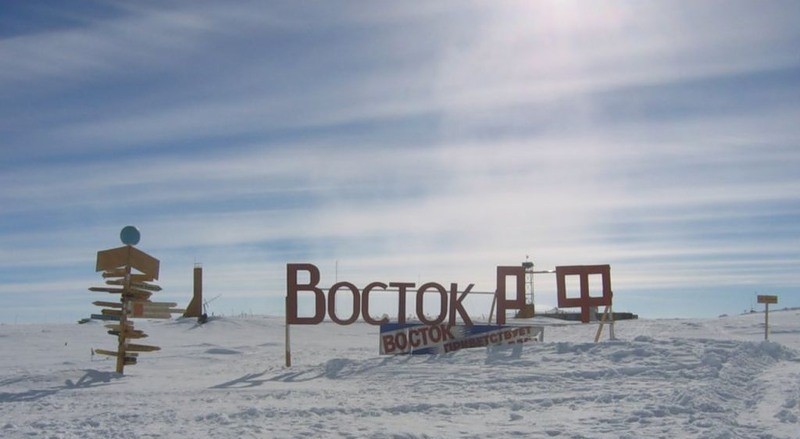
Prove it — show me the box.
[0,310,800,438]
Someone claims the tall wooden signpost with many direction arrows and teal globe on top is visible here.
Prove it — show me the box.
[89,226,183,373]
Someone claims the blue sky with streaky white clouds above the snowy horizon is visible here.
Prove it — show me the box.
[0,0,800,324]
